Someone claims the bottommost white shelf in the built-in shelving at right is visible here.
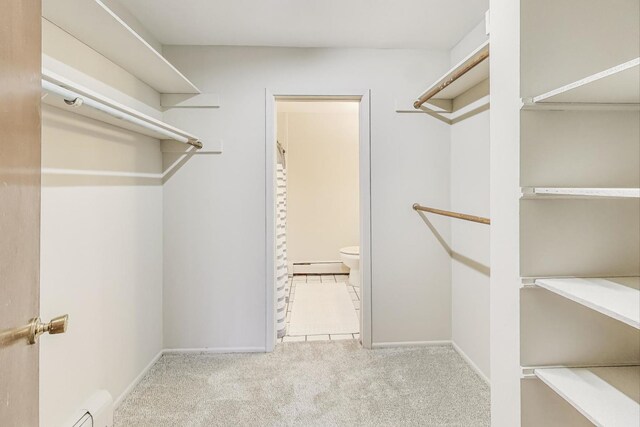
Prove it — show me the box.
[534,366,640,427]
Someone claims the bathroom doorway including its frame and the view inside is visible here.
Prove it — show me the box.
[266,93,371,350]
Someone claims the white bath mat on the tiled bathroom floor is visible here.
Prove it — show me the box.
[287,283,360,335]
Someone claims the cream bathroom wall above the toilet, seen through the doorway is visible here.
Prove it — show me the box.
[277,101,360,272]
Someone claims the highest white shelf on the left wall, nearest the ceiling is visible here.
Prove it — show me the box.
[42,0,200,93]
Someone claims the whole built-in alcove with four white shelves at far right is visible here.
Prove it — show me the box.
[519,0,640,427]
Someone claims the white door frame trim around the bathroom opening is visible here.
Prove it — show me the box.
[265,89,371,352]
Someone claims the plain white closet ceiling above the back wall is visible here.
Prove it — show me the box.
[120,0,489,49]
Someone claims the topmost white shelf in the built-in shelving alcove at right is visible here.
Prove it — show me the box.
[527,58,640,106]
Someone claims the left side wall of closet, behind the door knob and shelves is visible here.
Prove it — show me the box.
[40,21,162,427]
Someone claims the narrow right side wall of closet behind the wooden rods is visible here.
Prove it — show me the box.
[451,20,490,381]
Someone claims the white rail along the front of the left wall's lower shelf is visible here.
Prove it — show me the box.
[42,79,202,148]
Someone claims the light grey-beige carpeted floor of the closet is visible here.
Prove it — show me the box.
[115,340,490,427]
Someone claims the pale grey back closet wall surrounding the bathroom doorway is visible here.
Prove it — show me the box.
[159,46,451,349]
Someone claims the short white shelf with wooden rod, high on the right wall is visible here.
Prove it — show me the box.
[418,40,489,110]
